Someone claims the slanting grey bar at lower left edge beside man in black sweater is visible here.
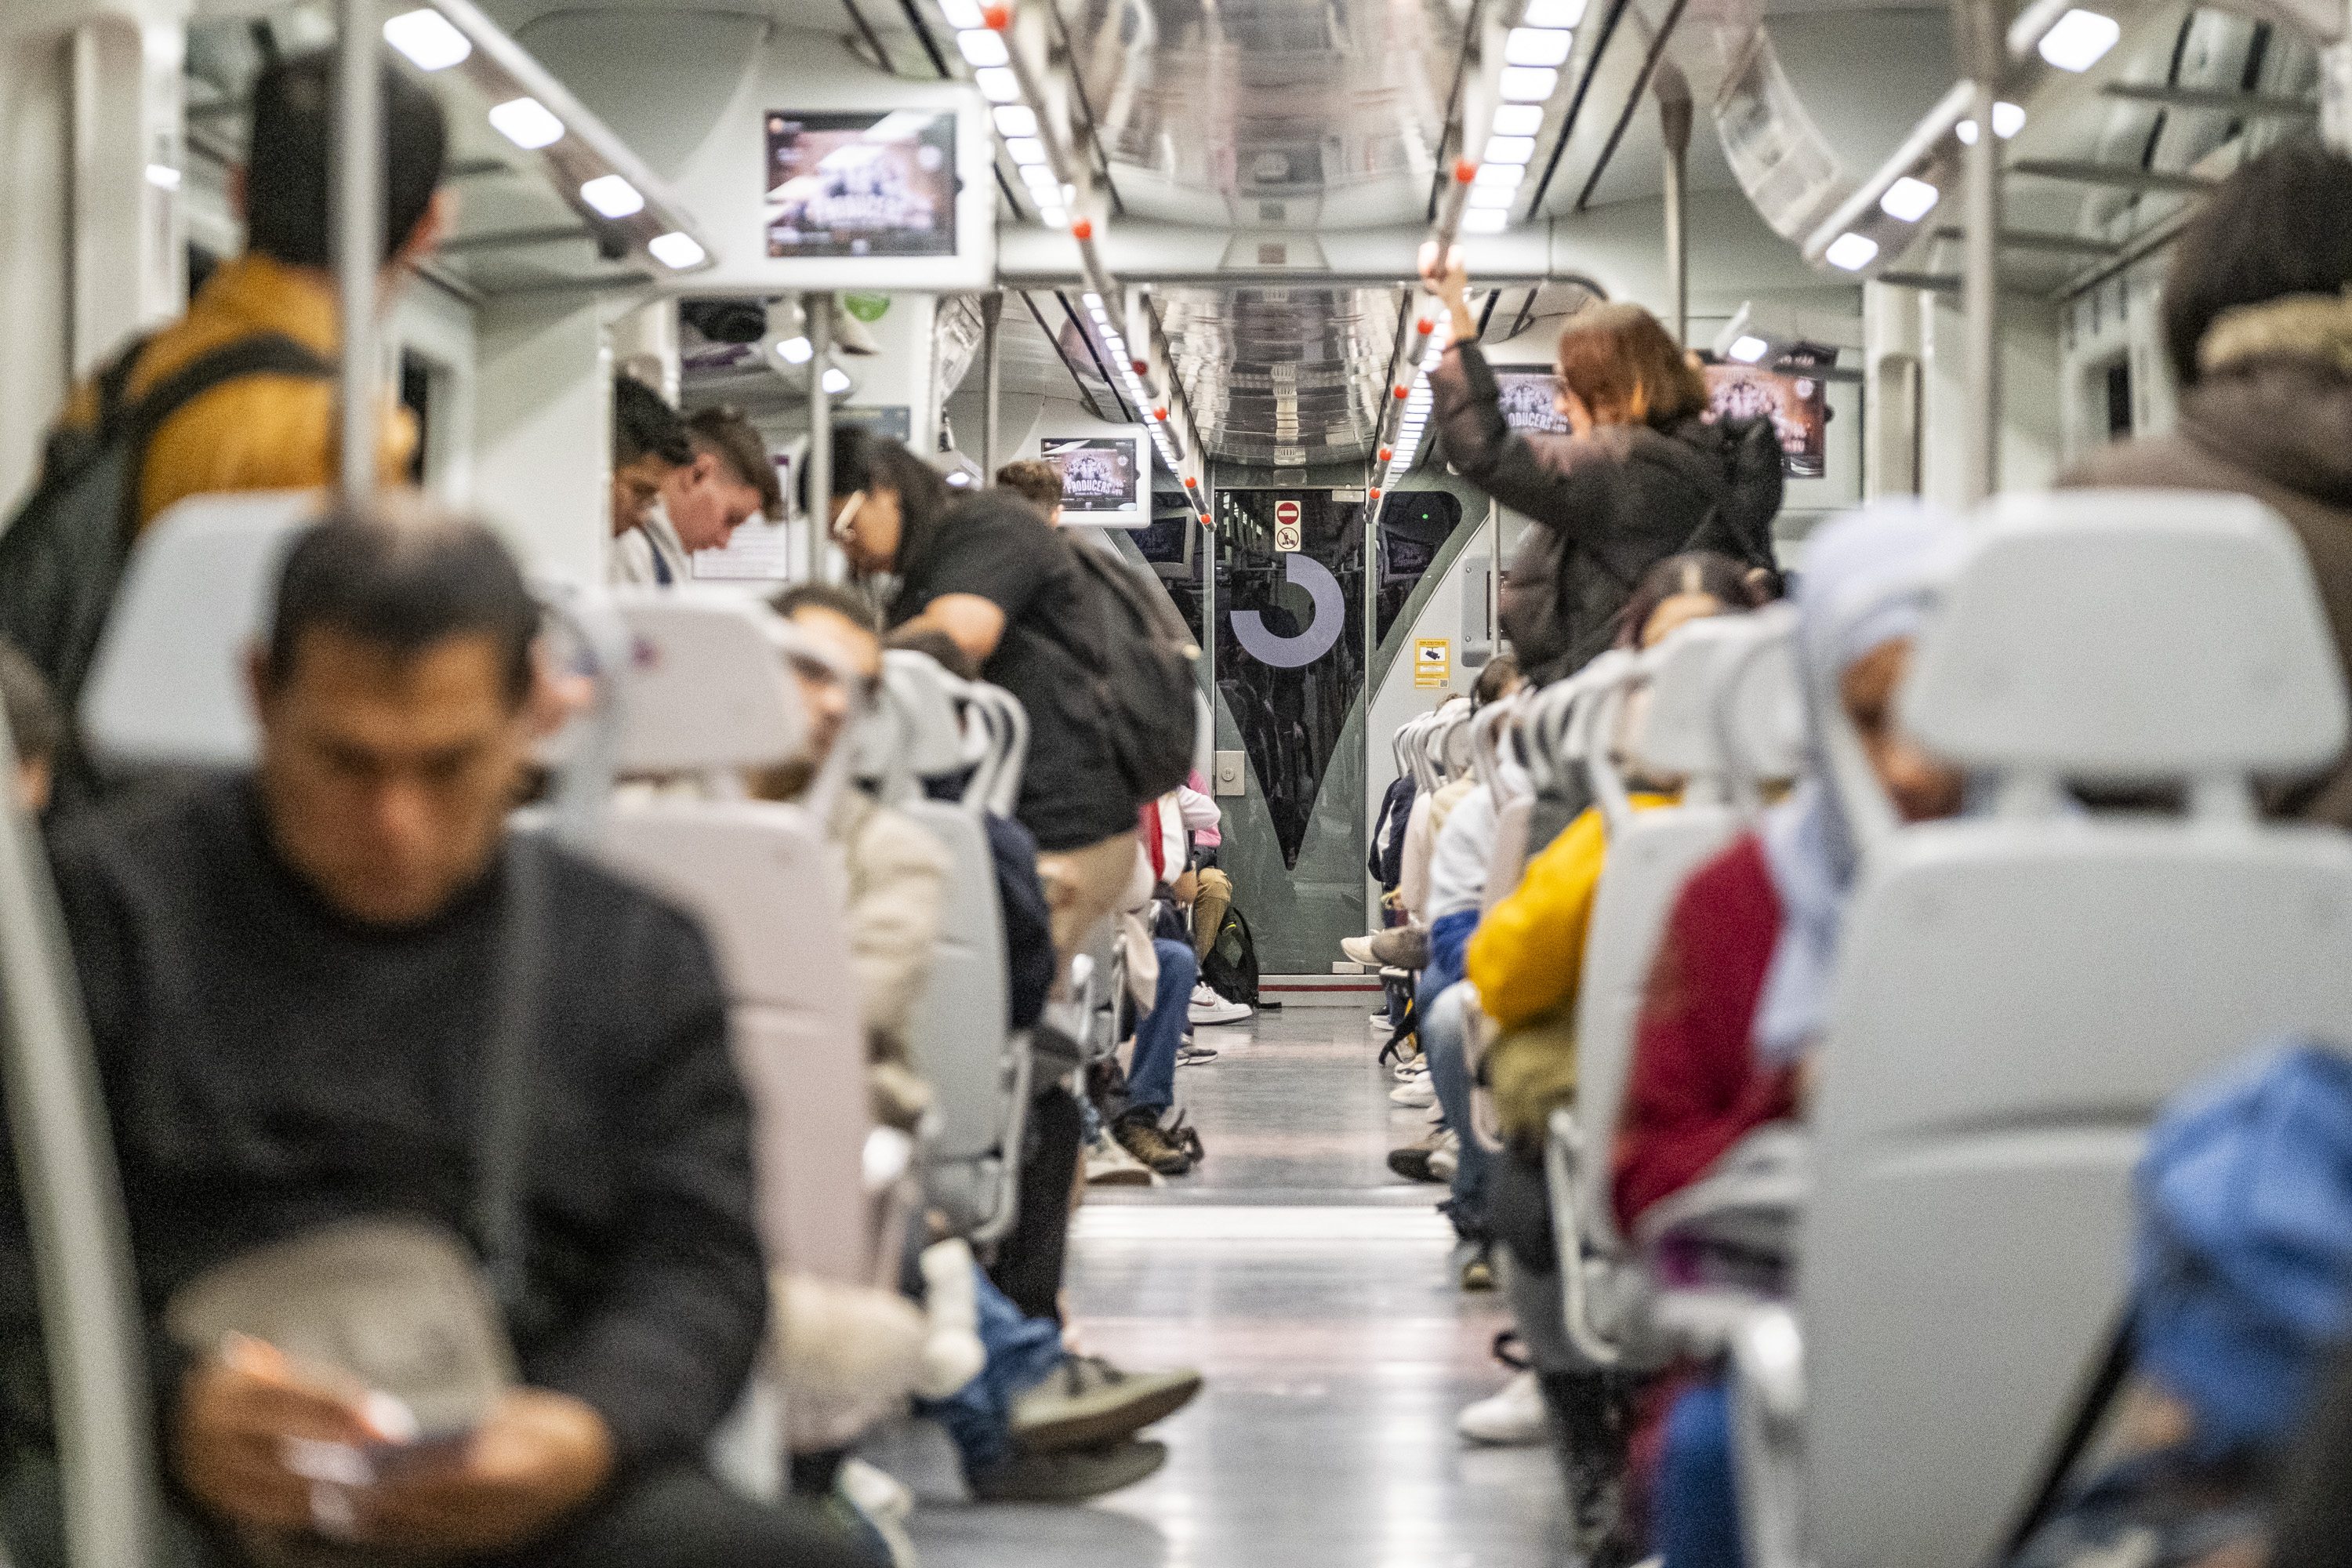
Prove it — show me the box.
[0,724,158,1568]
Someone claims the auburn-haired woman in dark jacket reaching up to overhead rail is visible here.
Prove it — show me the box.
[1423,247,1780,684]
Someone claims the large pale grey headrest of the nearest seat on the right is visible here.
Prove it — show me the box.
[1903,492,2347,783]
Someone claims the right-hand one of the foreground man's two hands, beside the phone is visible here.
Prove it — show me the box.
[355,1389,614,1556]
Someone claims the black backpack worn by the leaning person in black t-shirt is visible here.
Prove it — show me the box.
[1070,546,1200,806]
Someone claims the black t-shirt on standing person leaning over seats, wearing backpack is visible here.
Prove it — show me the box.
[889,492,1138,851]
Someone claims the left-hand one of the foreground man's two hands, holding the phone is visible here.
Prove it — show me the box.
[172,1335,388,1535]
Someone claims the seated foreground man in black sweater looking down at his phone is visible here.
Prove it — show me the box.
[0,508,861,1568]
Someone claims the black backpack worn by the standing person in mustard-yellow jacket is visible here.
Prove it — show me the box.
[0,332,334,715]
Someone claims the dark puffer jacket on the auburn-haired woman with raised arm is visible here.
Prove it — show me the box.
[1430,343,1780,682]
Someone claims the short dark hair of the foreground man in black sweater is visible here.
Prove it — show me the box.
[268,496,539,703]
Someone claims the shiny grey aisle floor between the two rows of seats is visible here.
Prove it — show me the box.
[910,1006,1566,1568]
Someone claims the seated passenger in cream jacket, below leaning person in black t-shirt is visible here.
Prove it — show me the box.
[760,583,950,1131]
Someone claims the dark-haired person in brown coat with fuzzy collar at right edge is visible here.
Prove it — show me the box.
[2060,141,2352,827]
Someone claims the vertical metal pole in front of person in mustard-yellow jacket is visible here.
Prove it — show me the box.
[329,0,383,503]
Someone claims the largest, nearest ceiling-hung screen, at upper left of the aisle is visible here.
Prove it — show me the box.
[764,108,955,261]
